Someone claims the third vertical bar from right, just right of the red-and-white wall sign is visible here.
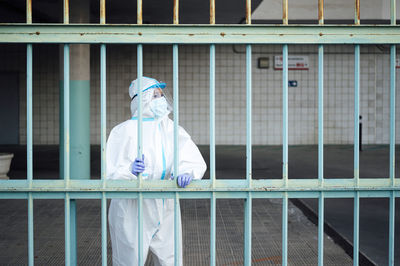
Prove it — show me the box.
[318,43,324,266]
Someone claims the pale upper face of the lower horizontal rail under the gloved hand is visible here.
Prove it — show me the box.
[0,178,400,191]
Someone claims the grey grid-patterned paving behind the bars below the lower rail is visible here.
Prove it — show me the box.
[0,199,352,266]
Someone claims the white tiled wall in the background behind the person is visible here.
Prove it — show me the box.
[0,45,400,145]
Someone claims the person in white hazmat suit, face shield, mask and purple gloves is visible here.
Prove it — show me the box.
[106,77,207,266]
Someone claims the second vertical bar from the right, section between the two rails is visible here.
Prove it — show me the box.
[354,44,360,186]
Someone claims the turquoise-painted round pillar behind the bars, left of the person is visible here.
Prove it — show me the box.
[60,0,90,265]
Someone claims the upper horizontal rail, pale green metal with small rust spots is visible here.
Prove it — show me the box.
[0,24,400,44]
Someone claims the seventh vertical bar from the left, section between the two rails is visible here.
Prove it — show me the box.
[246,44,252,187]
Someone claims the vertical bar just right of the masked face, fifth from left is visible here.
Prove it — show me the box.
[172,42,181,265]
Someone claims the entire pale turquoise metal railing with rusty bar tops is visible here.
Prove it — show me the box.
[0,0,400,265]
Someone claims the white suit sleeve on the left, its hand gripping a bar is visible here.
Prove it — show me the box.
[106,127,136,180]
